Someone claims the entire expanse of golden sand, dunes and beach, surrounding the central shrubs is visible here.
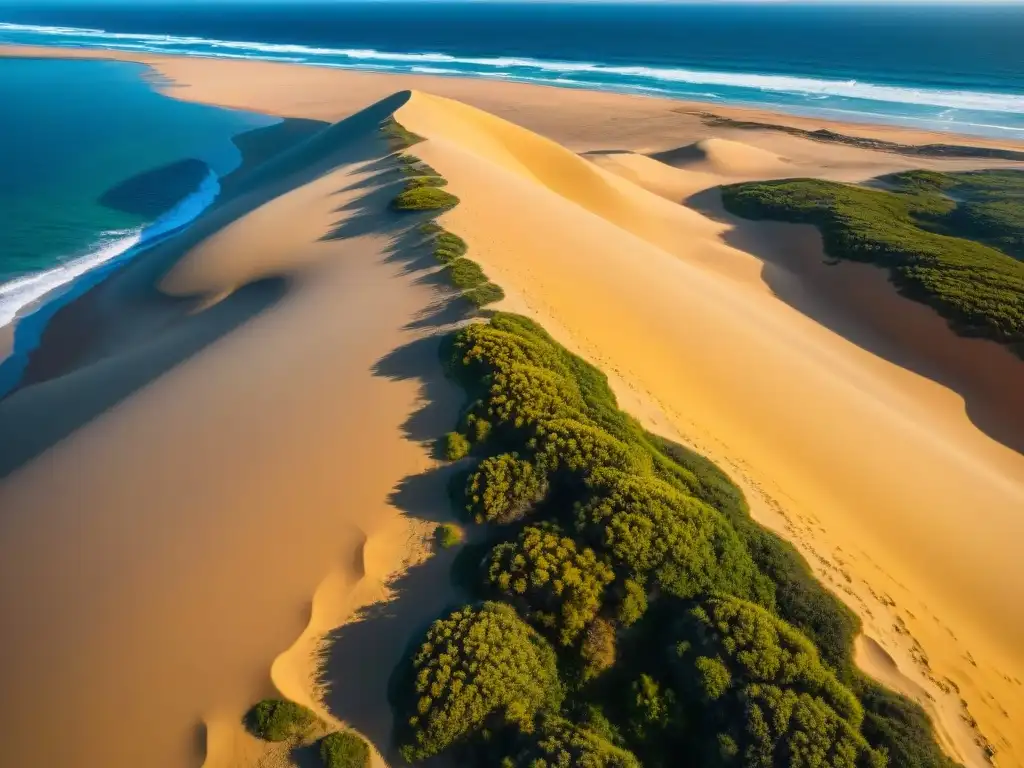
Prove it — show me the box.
[0,47,1024,768]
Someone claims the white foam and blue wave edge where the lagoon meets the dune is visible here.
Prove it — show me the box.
[0,171,220,397]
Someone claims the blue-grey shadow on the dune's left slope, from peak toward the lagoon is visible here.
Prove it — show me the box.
[0,92,409,478]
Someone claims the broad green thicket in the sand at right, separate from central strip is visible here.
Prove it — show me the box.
[722,171,1024,357]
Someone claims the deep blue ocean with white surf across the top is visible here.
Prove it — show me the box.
[0,0,1024,138]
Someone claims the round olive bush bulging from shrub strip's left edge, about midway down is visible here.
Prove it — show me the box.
[466,454,548,523]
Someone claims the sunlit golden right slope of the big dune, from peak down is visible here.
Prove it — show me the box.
[398,94,1024,765]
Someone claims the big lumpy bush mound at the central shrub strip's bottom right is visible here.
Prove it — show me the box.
[677,598,886,768]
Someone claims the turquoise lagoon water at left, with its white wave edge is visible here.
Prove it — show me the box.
[0,59,274,325]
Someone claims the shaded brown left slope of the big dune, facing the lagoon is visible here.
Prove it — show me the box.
[0,91,457,768]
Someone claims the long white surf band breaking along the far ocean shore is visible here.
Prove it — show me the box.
[0,23,1024,113]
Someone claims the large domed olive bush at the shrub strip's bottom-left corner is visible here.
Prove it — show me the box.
[401,603,563,760]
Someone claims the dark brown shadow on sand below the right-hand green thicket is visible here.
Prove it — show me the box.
[683,187,1024,454]
